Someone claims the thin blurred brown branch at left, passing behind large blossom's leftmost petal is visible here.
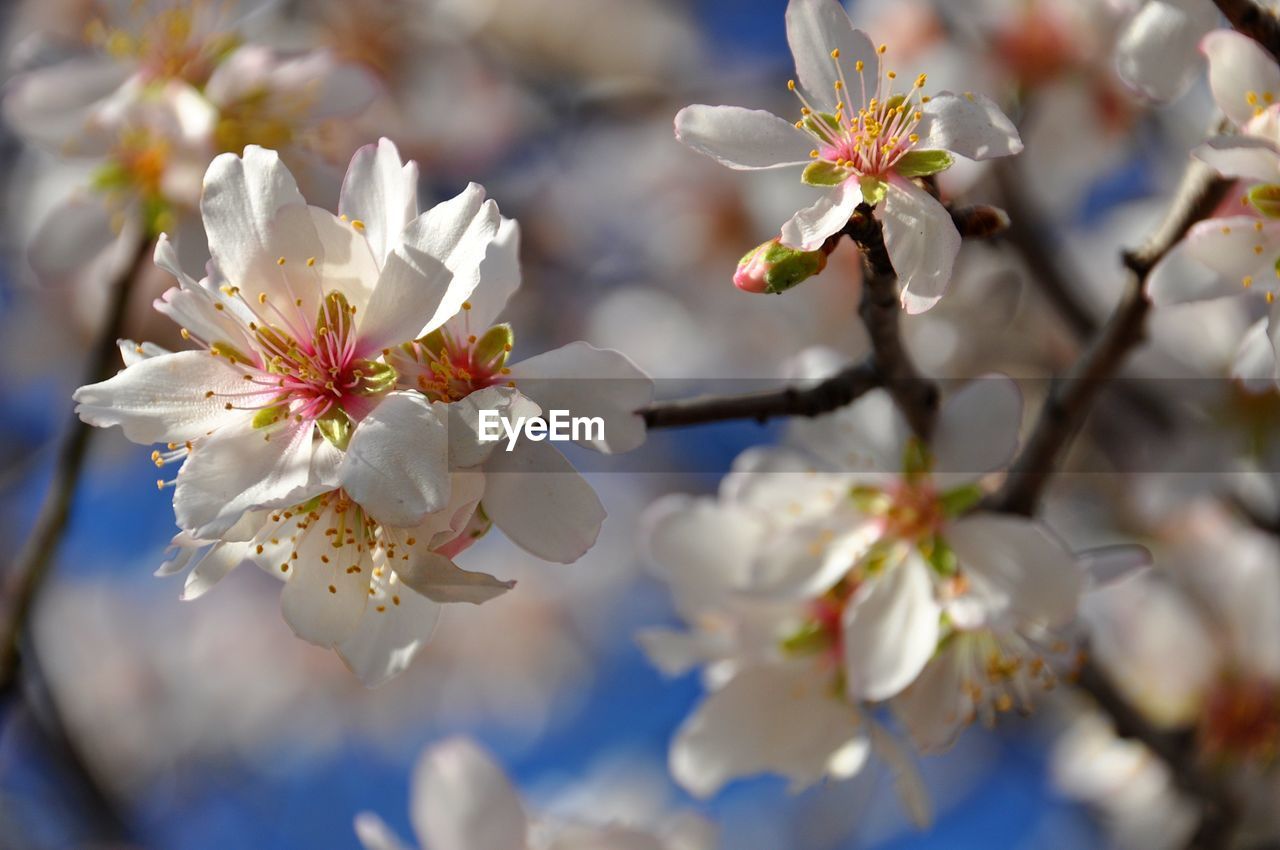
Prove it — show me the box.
[0,239,151,699]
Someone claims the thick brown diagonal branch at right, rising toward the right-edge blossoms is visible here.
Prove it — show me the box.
[987,160,1229,516]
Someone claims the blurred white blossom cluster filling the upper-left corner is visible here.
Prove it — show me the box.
[4,0,376,279]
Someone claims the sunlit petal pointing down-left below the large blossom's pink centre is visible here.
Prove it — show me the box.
[172,417,314,540]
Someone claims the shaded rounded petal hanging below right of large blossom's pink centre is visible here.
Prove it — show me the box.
[338,392,451,527]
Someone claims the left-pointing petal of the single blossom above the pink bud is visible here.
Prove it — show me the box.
[676,104,813,170]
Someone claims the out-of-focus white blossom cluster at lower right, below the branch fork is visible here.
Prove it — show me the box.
[643,363,1083,801]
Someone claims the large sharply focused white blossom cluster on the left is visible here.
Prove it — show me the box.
[76,140,653,684]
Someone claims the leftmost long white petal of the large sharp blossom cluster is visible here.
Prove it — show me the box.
[73,351,255,443]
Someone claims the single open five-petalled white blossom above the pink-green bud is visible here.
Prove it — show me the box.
[676,0,1021,312]
